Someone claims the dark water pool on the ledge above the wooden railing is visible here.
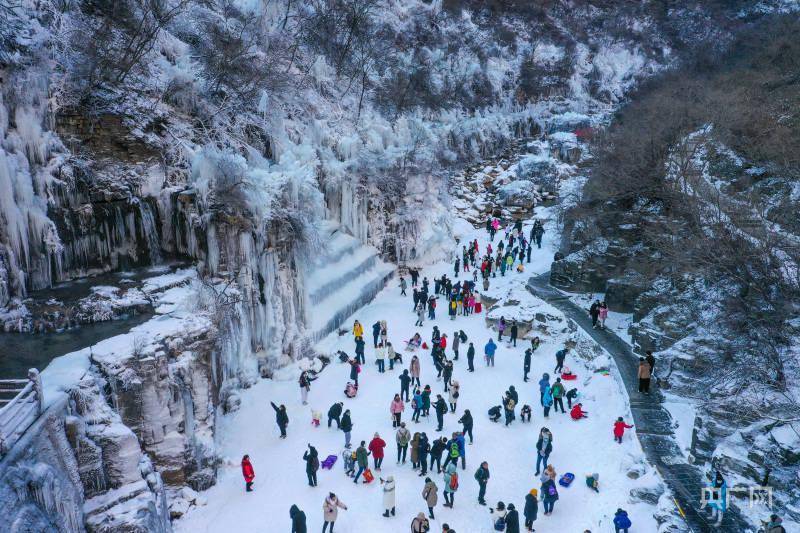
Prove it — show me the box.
[0,313,153,379]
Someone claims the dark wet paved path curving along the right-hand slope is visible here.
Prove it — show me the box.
[527,272,752,533]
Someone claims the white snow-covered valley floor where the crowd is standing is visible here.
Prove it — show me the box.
[174,208,660,533]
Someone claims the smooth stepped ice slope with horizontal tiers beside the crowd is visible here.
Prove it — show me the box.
[306,222,394,341]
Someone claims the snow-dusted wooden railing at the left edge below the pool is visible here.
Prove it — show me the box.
[0,368,44,455]
